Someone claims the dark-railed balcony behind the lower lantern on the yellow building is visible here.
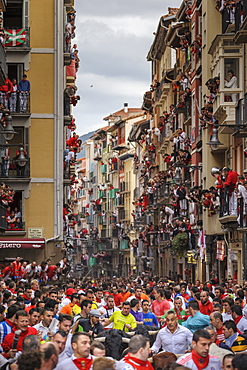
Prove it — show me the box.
[0,158,30,184]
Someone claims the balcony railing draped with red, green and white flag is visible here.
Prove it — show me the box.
[4,28,31,52]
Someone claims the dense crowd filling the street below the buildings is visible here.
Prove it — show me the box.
[0,268,247,370]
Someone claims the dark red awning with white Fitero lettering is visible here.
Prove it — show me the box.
[0,238,45,249]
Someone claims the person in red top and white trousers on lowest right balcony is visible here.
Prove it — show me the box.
[222,167,238,216]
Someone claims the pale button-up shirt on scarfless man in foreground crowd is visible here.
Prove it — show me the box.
[151,324,193,354]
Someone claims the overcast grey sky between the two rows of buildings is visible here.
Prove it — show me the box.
[74,0,182,135]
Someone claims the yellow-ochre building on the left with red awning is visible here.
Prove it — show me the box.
[0,0,74,263]
